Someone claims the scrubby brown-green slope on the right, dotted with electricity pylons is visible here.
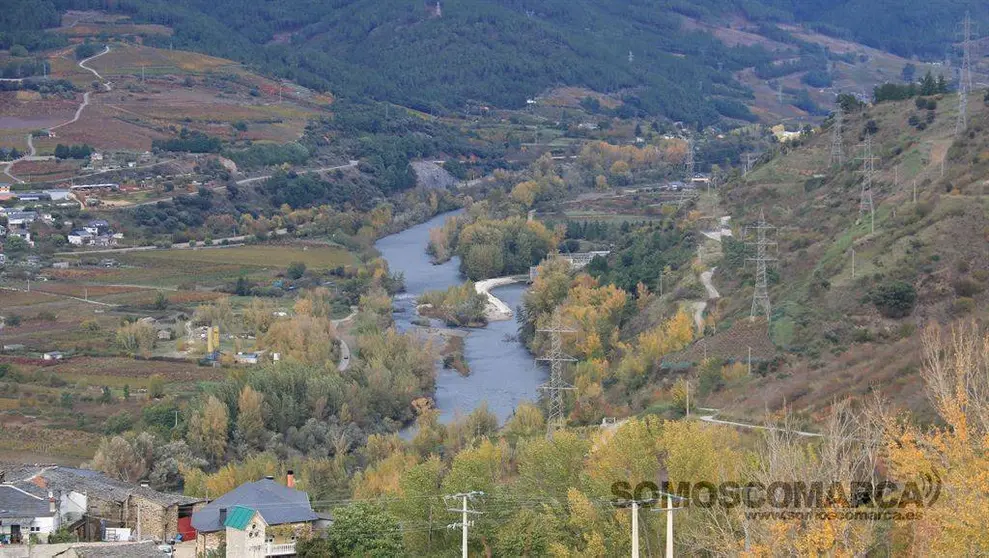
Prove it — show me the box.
[696,93,989,424]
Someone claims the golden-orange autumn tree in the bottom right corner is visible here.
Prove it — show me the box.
[884,323,989,556]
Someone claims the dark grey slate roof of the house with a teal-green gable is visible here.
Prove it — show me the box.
[192,479,319,533]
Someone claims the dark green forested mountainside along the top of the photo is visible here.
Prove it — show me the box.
[9,0,989,125]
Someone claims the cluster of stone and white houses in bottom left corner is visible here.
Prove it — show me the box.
[0,463,332,558]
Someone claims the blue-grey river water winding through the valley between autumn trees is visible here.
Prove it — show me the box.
[375,212,547,422]
